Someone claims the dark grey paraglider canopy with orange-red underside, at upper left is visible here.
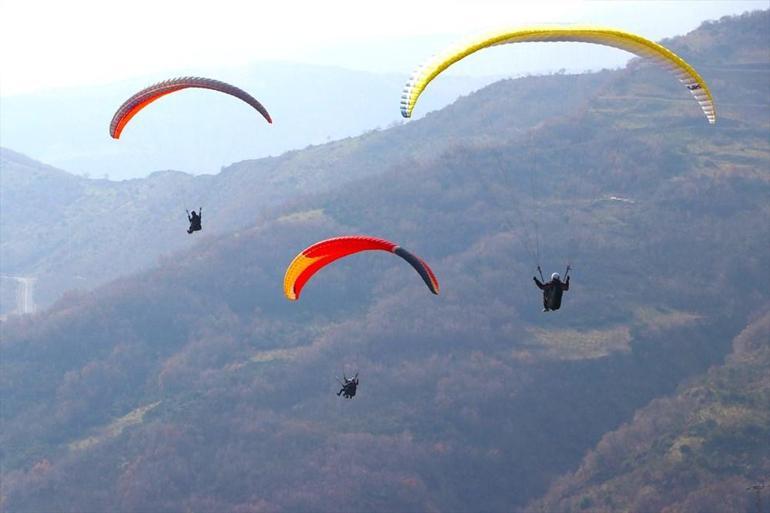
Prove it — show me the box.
[110,77,273,139]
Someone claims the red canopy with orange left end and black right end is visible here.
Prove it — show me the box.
[283,235,439,301]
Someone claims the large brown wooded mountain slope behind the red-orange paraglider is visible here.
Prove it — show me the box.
[0,9,770,512]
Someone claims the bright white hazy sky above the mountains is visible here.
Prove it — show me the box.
[0,0,770,95]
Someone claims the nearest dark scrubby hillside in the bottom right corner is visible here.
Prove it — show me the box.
[529,310,770,513]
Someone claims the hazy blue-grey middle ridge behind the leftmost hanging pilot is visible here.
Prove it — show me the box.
[0,68,611,313]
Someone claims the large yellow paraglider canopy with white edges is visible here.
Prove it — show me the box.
[401,26,716,125]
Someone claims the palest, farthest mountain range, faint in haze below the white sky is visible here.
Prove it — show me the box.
[0,62,498,180]
